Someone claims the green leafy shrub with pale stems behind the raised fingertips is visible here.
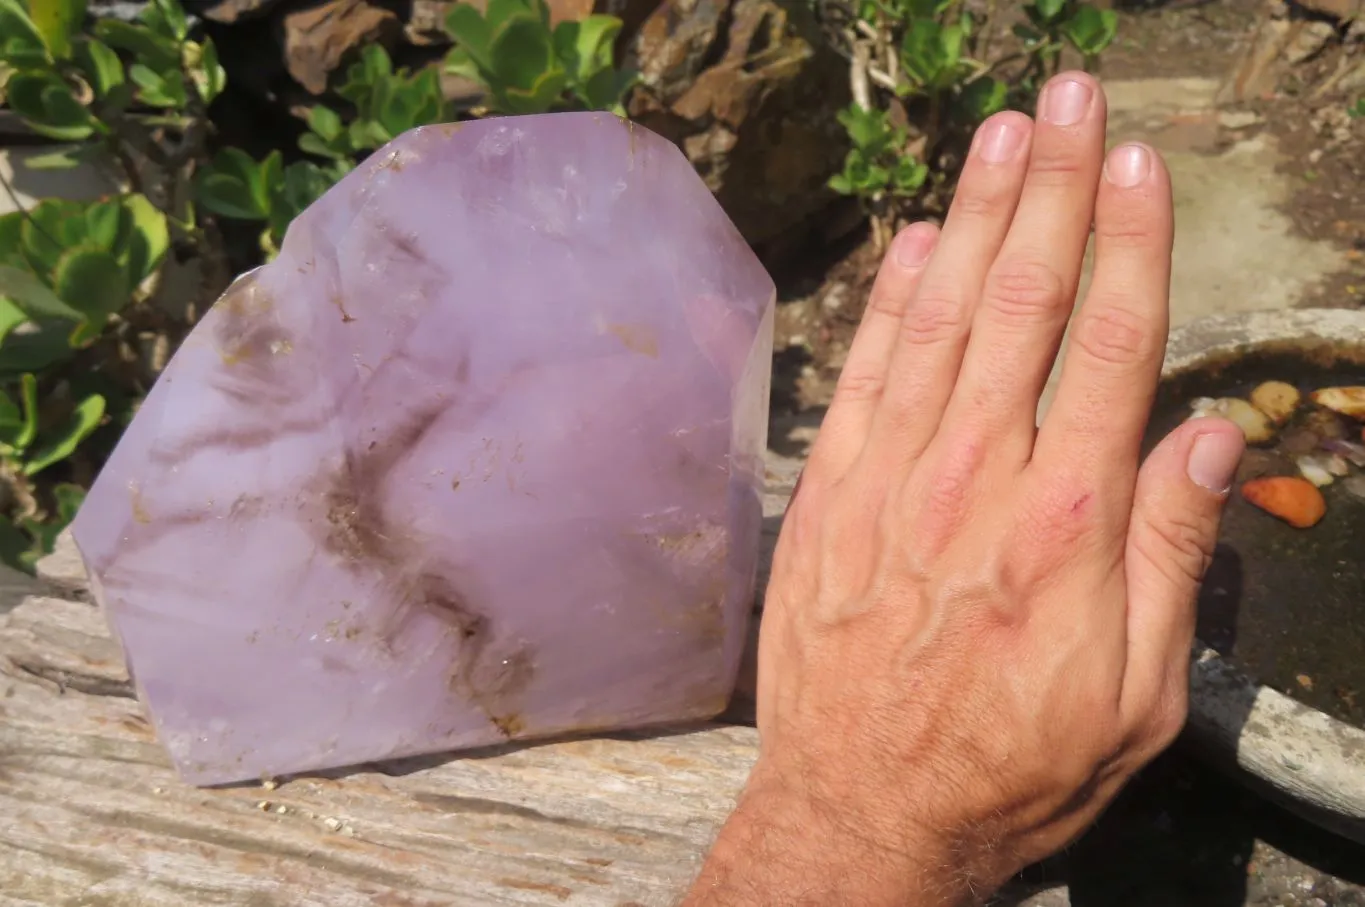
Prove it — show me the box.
[830,0,1118,240]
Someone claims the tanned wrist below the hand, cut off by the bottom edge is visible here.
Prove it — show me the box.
[680,777,976,907]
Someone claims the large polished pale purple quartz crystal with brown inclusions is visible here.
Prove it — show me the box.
[74,113,774,784]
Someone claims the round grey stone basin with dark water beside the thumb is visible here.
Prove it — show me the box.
[1148,309,1365,843]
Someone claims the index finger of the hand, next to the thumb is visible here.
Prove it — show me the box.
[1031,143,1175,502]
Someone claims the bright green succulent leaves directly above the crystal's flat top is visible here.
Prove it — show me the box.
[445,0,635,115]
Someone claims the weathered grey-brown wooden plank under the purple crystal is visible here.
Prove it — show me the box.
[0,450,799,907]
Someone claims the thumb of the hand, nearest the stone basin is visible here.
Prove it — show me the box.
[1123,418,1246,720]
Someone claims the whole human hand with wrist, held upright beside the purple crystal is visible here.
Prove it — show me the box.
[687,72,1244,907]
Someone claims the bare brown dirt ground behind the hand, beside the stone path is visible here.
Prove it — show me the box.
[773,0,1365,426]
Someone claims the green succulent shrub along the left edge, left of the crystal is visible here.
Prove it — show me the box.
[0,0,207,570]
